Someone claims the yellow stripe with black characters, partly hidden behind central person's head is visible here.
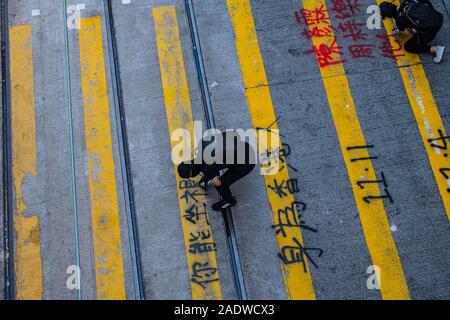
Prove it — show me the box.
[153,7,222,300]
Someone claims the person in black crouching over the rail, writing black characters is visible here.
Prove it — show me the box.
[178,131,256,211]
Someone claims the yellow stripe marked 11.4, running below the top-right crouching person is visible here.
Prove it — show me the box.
[377,0,450,220]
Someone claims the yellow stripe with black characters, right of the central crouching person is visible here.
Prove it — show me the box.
[227,0,315,300]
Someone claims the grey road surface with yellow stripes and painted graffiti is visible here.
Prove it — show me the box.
[0,0,450,300]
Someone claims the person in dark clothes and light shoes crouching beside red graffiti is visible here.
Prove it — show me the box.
[380,0,445,63]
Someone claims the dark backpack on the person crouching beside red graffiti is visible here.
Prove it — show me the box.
[402,0,444,33]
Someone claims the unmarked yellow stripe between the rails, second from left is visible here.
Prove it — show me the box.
[79,17,126,300]
